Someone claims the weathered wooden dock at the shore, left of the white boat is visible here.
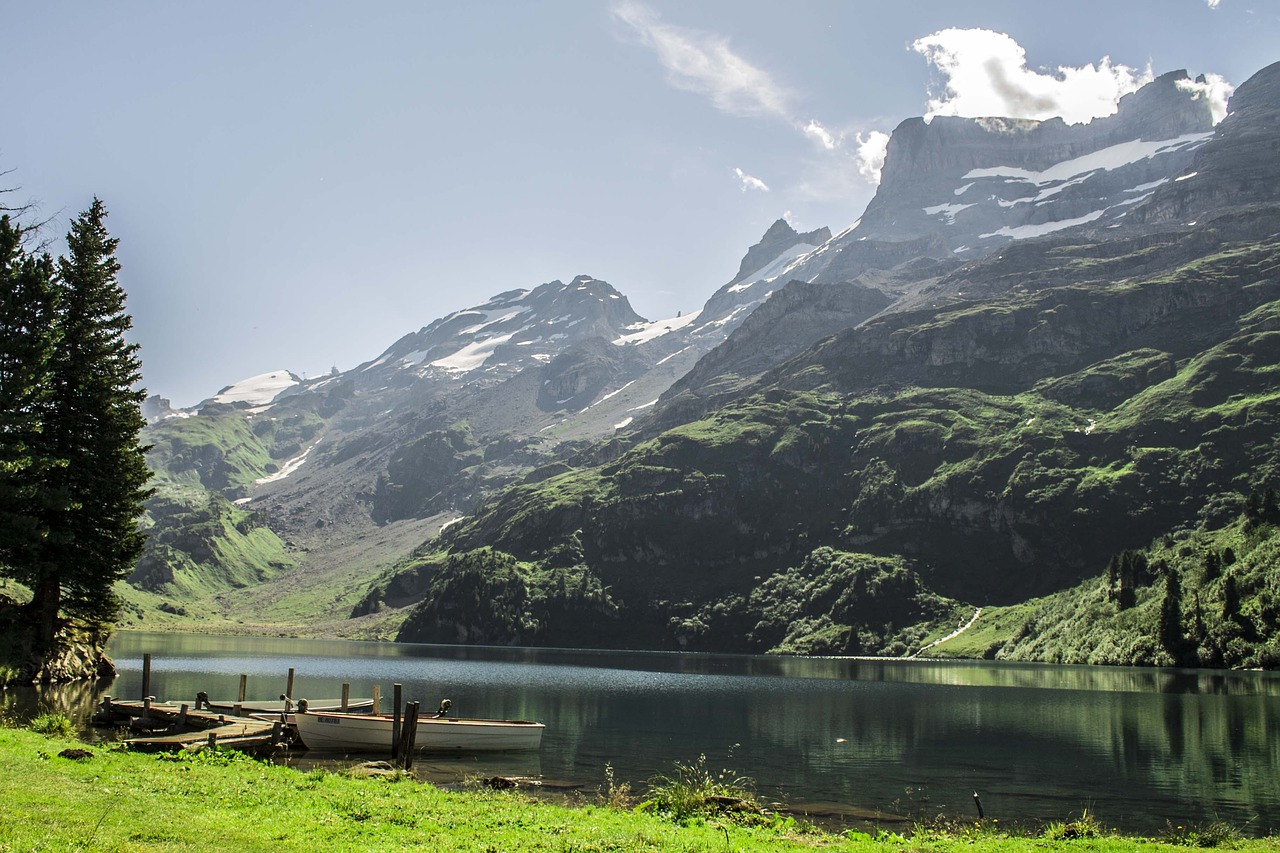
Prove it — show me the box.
[93,697,287,752]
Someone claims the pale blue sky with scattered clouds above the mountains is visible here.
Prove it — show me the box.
[0,0,1280,406]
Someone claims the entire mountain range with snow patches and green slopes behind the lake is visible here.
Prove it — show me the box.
[131,59,1280,663]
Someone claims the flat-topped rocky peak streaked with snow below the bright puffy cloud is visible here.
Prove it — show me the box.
[790,70,1213,289]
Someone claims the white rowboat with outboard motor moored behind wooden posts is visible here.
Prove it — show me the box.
[293,711,547,752]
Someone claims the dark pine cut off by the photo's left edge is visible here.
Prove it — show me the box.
[0,214,58,585]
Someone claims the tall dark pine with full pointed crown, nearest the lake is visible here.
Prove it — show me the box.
[31,199,151,649]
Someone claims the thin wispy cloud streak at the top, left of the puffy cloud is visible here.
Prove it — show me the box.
[613,0,788,118]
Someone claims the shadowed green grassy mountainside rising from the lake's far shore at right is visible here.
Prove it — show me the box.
[373,240,1280,662]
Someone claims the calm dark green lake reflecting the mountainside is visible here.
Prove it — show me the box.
[3,633,1280,834]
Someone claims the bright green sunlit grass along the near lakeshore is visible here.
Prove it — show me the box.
[0,727,1280,853]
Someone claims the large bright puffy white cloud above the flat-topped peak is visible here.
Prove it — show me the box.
[911,28,1152,124]
